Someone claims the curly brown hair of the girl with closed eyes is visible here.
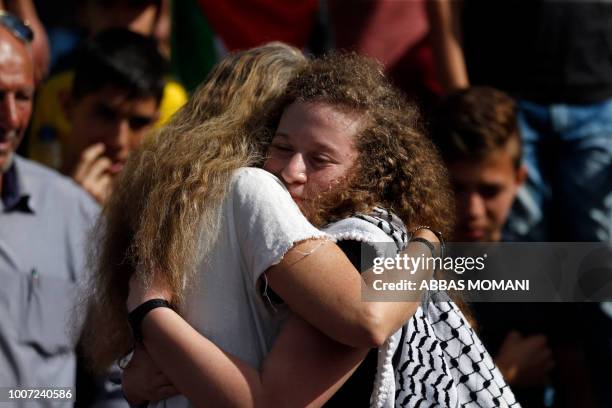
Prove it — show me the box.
[277,53,454,236]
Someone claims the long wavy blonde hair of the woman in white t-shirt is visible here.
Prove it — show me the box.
[85,43,306,370]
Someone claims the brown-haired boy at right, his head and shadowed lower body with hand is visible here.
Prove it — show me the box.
[432,87,553,407]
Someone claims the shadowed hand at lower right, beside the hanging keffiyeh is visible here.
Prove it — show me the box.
[495,331,554,387]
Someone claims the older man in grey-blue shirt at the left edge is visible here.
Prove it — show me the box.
[0,13,124,406]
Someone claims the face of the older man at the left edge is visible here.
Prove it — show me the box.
[0,28,34,173]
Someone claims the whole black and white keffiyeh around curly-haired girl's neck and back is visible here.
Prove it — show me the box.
[324,208,520,408]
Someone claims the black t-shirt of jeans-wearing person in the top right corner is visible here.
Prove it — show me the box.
[462,0,612,104]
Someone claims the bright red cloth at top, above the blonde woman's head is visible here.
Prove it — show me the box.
[198,0,319,51]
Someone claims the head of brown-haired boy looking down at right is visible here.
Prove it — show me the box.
[432,87,527,242]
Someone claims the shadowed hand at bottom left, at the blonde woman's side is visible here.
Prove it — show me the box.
[121,344,179,405]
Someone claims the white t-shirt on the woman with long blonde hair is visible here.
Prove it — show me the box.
[152,168,326,407]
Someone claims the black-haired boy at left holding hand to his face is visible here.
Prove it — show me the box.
[61,28,166,203]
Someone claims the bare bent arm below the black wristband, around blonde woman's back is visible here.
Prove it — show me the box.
[131,308,367,407]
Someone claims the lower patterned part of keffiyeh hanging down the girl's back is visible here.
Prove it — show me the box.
[388,292,519,408]
